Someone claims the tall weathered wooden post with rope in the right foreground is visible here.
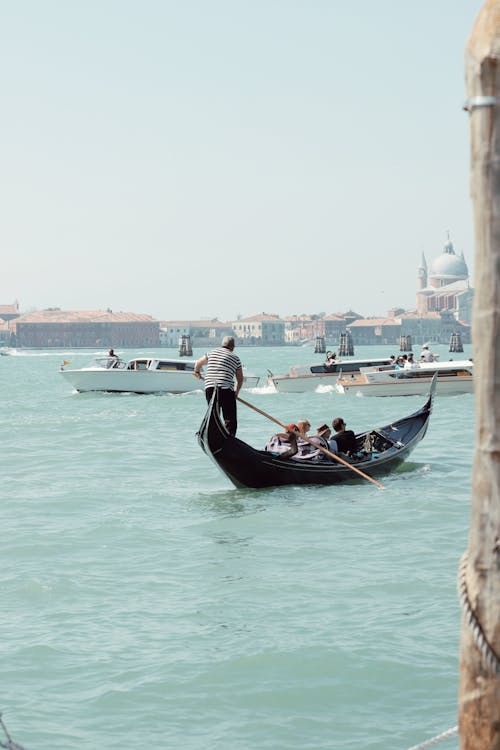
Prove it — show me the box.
[459,0,500,750]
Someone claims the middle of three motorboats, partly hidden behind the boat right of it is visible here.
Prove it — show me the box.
[269,357,391,393]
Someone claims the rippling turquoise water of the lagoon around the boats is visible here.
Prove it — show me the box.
[0,347,474,750]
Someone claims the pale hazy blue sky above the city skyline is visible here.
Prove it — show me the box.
[0,0,483,320]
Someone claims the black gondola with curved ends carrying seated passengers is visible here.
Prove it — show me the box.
[197,379,436,488]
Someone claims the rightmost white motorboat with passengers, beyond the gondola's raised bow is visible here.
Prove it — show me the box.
[336,359,474,396]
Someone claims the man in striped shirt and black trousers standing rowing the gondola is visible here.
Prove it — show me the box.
[194,336,243,435]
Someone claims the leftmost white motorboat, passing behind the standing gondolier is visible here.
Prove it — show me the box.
[61,357,259,393]
